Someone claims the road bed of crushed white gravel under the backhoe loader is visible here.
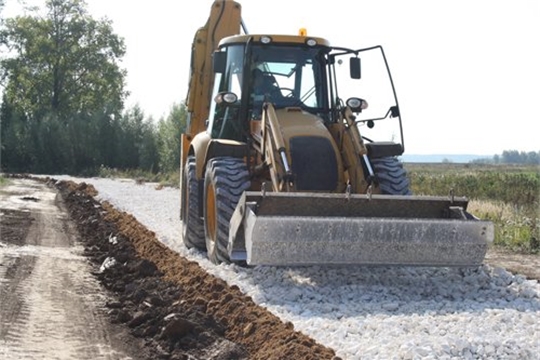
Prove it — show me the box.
[44,176,540,359]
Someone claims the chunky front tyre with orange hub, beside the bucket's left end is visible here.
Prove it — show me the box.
[204,157,250,264]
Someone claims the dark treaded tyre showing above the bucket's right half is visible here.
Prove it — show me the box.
[371,157,412,195]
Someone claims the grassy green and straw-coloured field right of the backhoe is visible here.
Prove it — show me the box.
[404,163,540,253]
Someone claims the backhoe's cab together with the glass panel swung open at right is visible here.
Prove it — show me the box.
[207,35,404,157]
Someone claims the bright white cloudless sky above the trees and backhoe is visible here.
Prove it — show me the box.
[4,0,540,155]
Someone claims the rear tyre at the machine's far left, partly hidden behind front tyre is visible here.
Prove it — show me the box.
[181,156,206,250]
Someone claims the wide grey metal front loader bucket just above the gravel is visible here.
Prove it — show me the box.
[229,192,494,266]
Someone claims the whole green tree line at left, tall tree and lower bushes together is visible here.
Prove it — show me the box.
[0,0,187,174]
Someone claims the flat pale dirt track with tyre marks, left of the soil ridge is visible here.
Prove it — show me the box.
[0,181,142,359]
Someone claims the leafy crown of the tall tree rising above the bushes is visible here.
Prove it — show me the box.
[1,0,126,120]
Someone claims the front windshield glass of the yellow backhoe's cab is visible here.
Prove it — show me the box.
[251,45,328,111]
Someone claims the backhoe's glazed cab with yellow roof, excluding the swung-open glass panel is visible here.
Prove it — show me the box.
[208,35,330,141]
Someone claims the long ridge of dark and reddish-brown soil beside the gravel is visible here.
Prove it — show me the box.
[48,179,337,360]
